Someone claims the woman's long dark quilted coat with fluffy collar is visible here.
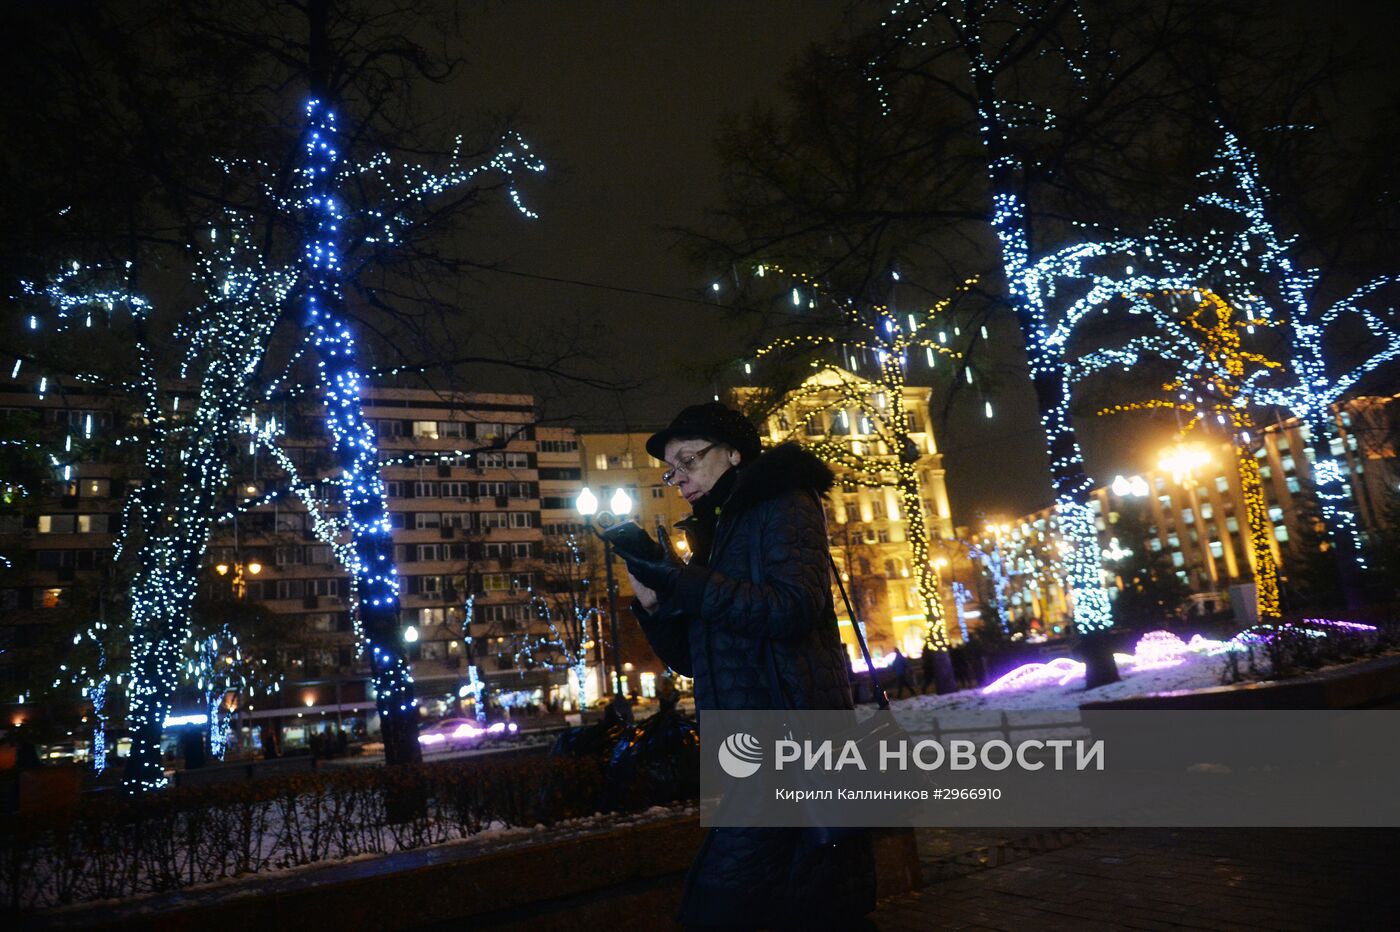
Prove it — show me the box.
[633,444,875,929]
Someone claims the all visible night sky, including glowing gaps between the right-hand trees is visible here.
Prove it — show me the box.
[10,0,1400,523]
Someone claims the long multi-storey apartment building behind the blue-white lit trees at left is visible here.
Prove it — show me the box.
[0,383,580,744]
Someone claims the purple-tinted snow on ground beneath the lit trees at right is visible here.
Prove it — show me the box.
[890,638,1224,712]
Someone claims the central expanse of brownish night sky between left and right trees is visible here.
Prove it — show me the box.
[452,0,843,417]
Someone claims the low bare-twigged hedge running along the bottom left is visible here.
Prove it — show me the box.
[0,757,618,910]
